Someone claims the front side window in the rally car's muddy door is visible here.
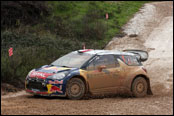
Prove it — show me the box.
[94,55,116,69]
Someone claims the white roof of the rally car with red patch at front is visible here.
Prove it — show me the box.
[75,49,135,55]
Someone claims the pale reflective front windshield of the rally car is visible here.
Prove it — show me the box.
[51,52,93,68]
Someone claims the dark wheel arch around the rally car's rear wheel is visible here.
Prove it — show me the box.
[131,74,153,95]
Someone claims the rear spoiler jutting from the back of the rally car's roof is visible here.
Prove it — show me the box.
[123,49,149,62]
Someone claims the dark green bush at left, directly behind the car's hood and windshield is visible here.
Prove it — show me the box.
[1,31,81,86]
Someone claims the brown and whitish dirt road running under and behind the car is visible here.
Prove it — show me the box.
[1,2,173,115]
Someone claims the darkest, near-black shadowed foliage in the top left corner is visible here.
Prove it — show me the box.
[1,1,49,28]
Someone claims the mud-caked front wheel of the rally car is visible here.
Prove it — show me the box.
[66,78,85,100]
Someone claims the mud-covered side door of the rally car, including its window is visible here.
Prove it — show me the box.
[87,55,122,92]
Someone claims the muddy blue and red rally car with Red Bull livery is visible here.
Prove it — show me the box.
[25,49,152,99]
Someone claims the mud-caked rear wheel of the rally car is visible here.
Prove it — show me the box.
[132,77,148,97]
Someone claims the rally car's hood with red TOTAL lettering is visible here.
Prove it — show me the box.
[28,66,76,79]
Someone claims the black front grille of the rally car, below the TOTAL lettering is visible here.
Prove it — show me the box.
[27,78,47,92]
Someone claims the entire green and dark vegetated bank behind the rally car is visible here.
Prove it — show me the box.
[1,1,146,87]
